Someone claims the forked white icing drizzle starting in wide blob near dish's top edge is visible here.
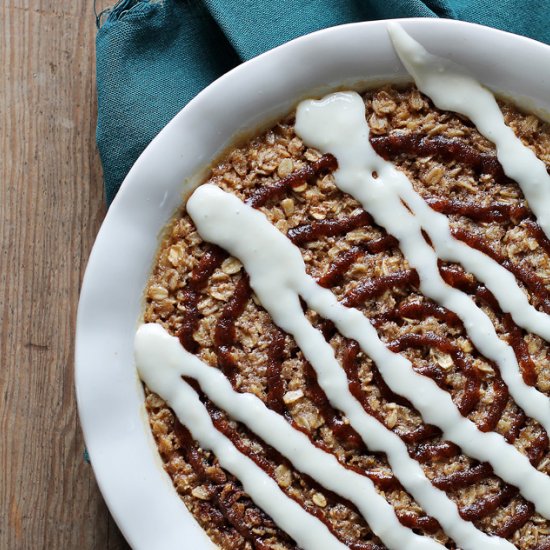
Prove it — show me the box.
[296,92,550,442]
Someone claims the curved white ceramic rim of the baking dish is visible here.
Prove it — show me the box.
[76,19,550,550]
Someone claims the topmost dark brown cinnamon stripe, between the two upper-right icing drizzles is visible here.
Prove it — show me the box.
[370,132,511,182]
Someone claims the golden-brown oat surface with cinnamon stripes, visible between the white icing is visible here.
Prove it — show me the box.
[144,86,550,550]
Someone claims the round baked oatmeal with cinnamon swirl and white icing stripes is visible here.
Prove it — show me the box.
[136,28,550,550]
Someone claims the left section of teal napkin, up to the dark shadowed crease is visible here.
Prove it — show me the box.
[97,0,240,204]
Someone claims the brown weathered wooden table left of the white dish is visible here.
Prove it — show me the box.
[0,0,128,550]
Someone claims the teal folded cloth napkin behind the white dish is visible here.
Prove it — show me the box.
[97,0,550,203]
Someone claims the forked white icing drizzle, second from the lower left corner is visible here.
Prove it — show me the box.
[187,184,536,549]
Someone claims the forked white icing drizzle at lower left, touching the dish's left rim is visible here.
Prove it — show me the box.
[135,323,444,550]
